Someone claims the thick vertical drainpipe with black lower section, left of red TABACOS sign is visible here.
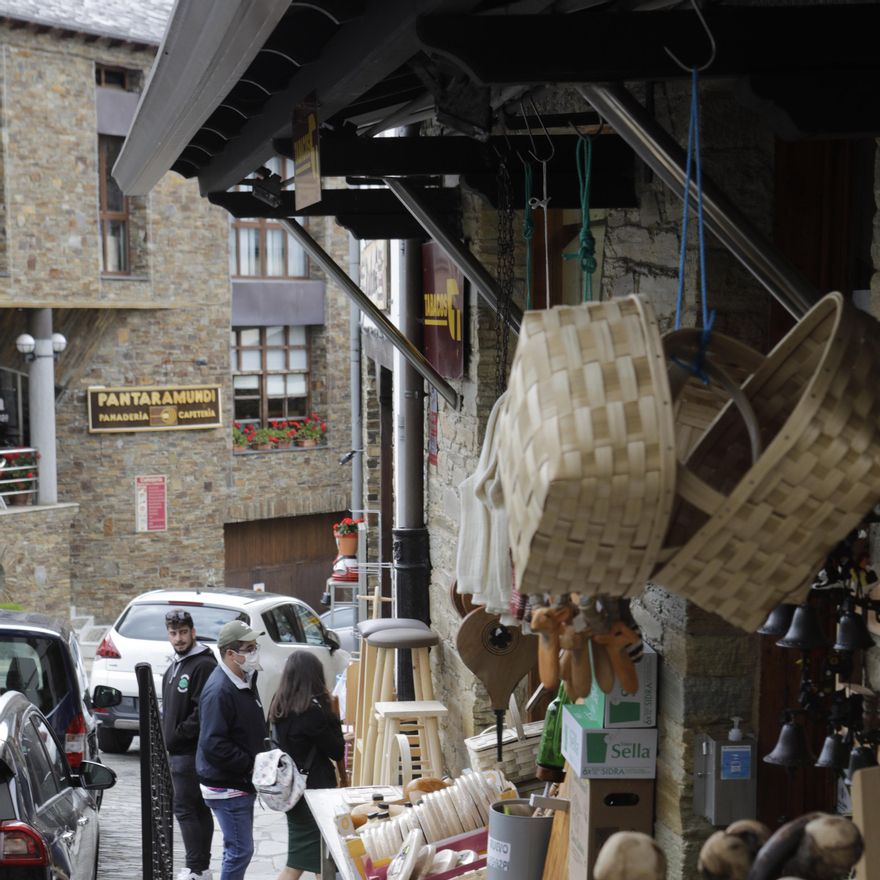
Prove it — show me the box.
[392,240,430,700]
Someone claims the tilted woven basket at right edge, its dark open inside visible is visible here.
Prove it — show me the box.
[651,293,880,631]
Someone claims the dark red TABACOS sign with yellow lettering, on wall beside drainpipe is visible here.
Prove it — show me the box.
[422,241,464,379]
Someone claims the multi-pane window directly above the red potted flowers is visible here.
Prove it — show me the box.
[230,327,309,427]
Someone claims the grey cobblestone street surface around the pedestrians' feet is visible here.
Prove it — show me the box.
[98,737,315,880]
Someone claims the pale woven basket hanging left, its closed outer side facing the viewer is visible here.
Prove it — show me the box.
[497,296,675,596]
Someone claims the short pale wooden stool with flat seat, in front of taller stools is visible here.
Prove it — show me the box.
[373,700,447,785]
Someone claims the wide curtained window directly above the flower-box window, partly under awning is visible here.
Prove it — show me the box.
[229,157,309,278]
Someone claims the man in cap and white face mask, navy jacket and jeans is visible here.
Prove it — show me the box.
[196,620,268,880]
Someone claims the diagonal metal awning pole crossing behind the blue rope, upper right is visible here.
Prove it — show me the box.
[576,84,819,318]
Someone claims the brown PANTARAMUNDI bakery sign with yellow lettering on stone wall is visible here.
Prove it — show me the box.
[89,385,221,434]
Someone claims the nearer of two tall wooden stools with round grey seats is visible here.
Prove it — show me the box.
[358,624,440,785]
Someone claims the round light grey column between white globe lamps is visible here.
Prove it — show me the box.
[28,309,58,504]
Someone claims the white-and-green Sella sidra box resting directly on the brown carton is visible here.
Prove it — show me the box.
[562,705,657,779]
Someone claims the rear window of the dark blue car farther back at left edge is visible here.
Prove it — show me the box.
[0,633,70,715]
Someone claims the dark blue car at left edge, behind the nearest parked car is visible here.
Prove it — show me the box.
[0,611,105,770]
